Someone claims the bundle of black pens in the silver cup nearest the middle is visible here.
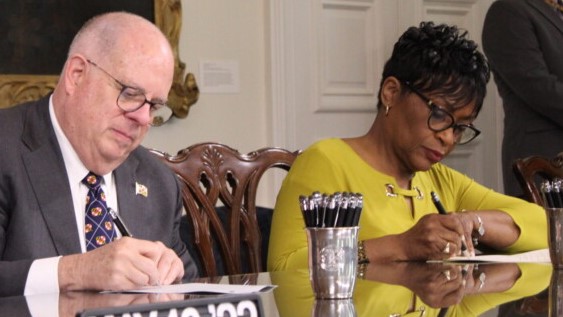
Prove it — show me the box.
[299,192,364,228]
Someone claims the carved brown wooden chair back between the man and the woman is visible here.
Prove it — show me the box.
[152,143,298,276]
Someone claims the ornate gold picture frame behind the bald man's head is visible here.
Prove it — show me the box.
[0,0,199,118]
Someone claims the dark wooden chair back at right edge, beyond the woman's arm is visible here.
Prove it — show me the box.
[512,152,563,206]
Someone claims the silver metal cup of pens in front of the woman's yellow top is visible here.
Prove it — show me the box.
[305,227,359,299]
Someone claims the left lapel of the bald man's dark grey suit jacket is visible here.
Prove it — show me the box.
[22,98,81,255]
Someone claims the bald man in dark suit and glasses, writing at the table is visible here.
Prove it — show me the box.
[0,13,197,296]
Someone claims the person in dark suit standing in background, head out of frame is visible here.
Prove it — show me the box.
[483,0,563,196]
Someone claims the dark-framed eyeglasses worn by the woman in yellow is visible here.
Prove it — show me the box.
[401,81,481,145]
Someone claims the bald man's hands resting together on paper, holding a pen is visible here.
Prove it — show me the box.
[58,237,184,291]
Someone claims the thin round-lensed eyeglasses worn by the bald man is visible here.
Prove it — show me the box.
[86,59,171,123]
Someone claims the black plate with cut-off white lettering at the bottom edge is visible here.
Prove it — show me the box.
[76,294,264,317]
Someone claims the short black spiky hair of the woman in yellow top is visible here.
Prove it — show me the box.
[378,22,490,116]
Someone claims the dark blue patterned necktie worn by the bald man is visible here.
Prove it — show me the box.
[82,172,116,251]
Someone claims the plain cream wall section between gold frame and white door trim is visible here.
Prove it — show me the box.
[143,0,270,154]
